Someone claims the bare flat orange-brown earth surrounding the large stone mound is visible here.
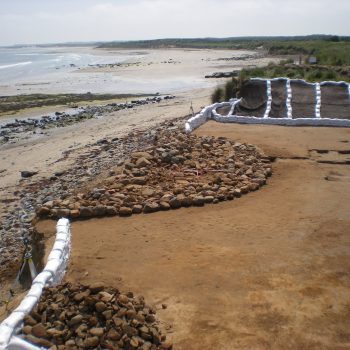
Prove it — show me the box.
[38,122,350,350]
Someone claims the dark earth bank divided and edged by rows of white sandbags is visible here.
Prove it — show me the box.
[186,78,350,132]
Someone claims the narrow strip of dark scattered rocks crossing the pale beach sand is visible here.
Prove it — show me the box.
[0,95,175,145]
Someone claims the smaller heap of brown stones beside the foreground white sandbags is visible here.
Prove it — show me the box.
[21,283,172,350]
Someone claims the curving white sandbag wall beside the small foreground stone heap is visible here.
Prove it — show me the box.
[0,219,71,350]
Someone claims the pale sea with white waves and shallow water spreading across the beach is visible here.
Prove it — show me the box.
[0,46,213,96]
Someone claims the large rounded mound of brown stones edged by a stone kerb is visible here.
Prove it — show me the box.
[37,130,271,219]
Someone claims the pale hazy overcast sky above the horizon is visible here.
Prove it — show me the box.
[0,0,350,45]
